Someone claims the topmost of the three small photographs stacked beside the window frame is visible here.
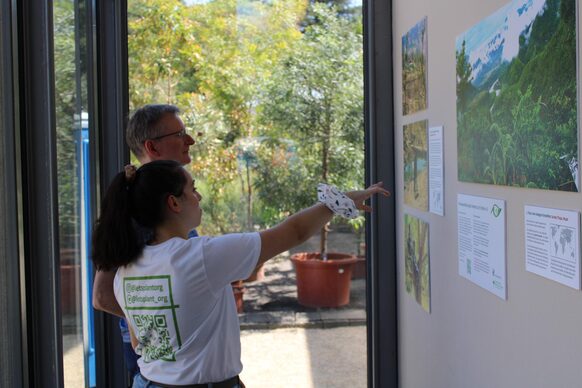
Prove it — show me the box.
[402,17,428,116]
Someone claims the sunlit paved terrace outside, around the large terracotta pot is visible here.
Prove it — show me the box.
[239,233,367,388]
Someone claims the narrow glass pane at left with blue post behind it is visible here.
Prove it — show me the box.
[53,0,95,387]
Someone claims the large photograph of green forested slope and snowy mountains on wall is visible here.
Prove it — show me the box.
[455,0,579,191]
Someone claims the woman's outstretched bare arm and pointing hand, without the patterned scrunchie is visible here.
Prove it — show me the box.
[257,182,390,266]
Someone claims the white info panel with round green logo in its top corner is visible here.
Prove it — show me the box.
[457,194,507,299]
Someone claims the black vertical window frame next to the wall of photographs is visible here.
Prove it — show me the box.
[363,0,398,388]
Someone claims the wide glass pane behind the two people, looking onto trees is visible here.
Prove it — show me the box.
[128,0,366,386]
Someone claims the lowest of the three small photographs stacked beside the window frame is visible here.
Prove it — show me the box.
[404,214,430,313]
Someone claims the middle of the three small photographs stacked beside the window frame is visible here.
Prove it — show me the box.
[403,120,428,211]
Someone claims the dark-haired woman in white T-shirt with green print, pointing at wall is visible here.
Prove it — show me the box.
[93,161,389,388]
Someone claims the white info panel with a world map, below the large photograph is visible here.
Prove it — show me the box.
[524,206,580,290]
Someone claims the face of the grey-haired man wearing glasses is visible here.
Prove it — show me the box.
[151,113,194,165]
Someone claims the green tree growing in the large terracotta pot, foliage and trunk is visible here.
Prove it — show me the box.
[256,4,364,257]
